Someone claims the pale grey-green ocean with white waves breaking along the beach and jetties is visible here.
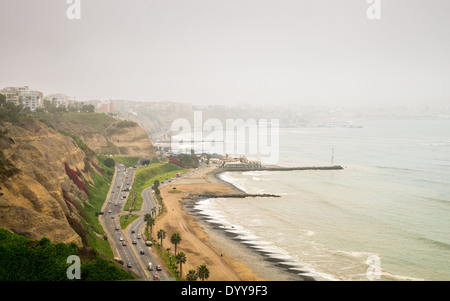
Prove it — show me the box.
[194,119,450,280]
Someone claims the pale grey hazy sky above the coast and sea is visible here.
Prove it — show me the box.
[0,0,450,105]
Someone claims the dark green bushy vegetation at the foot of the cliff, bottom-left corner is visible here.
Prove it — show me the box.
[0,229,135,281]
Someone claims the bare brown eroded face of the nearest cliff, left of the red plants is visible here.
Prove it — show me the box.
[0,118,95,246]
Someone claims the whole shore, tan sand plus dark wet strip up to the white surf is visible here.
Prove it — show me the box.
[153,168,315,281]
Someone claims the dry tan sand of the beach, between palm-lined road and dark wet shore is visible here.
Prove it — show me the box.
[153,168,265,281]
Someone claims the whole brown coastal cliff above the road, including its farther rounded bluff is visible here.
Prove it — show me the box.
[0,114,158,246]
